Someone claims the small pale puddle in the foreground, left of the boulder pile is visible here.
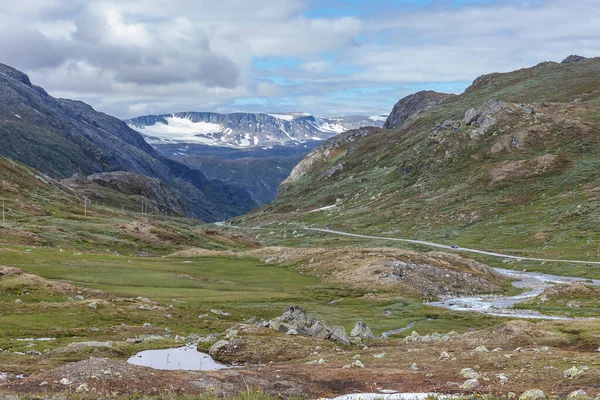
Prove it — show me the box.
[127,345,228,371]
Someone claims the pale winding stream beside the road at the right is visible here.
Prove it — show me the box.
[427,268,600,320]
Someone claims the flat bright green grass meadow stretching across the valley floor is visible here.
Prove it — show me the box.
[0,247,506,356]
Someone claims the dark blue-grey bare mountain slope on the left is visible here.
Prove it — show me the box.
[0,64,256,221]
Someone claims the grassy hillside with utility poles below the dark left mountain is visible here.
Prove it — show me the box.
[0,157,255,255]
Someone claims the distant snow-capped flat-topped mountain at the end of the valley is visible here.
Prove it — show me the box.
[125,112,386,148]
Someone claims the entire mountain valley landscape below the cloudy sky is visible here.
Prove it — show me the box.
[0,53,600,400]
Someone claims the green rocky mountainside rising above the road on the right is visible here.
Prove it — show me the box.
[234,57,600,260]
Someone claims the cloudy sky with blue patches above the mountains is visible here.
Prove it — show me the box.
[0,0,600,118]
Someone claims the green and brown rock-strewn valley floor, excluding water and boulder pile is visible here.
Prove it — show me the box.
[0,239,600,400]
